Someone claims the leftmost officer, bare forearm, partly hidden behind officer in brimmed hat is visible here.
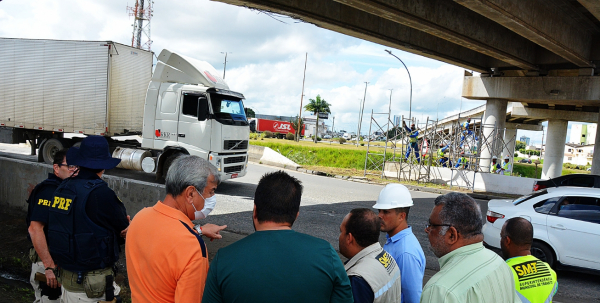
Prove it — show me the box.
[26,149,76,302]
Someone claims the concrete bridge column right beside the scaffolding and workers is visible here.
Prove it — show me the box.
[479,99,508,172]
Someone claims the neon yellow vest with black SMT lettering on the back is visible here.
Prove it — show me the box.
[506,255,558,303]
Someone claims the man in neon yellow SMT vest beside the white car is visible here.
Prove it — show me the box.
[500,217,558,303]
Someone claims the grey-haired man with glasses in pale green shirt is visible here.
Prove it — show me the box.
[421,193,520,303]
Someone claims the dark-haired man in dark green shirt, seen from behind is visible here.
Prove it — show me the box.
[202,171,353,303]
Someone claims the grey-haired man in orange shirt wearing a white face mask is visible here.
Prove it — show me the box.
[125,155,226,302]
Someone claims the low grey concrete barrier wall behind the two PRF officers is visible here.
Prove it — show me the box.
[0,158,165,217]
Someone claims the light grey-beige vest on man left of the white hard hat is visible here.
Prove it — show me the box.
[344,243,402,303]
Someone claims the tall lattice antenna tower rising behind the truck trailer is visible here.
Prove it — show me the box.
[127,0,154,50]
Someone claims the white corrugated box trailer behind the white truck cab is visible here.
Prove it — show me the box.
[0,38,153,136]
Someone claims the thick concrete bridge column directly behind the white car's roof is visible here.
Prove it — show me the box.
[542,119,568,180]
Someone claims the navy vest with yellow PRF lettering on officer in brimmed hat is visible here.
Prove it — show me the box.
[48,178,119,272]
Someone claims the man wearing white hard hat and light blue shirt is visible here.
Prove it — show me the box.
[373,184,425,303]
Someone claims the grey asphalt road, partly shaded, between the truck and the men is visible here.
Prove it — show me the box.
[0,144,600,302]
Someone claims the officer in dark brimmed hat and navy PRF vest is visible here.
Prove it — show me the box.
[48,136,129,302]
